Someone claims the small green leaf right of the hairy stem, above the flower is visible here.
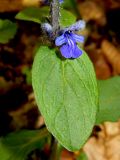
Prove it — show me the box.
[60,9,76,27]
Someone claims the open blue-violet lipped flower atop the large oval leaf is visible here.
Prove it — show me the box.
[55,30,84,58]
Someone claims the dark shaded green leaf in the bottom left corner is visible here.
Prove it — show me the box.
[0,129,48,160]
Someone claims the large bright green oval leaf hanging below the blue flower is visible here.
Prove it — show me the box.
[32,47,98,151]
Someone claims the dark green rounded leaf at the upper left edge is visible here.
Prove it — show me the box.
[0,19,17,44]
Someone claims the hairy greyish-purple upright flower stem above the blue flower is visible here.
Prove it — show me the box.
[50,0,60,39]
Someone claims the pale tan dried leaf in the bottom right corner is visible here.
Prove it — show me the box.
[84,122,120,160]
